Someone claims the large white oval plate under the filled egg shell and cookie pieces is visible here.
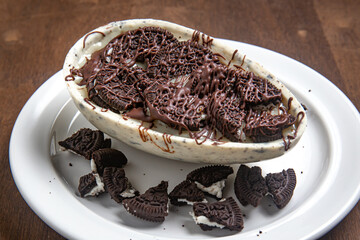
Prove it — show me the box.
[9,40,360,240]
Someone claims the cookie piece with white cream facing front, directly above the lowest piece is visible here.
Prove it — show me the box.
[186,165,234,199]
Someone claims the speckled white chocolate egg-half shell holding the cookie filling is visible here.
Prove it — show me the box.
[63,19,307,164]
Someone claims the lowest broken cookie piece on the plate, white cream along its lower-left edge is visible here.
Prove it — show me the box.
[191,197,244,232]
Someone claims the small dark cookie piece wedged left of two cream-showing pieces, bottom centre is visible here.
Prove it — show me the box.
[169,180,207,206]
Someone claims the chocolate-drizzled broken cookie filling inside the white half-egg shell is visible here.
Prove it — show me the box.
[65,27,299,143]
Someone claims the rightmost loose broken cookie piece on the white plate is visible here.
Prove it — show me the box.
[265,168,296,209]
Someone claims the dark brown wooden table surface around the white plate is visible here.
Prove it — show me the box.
[0,0,360,240]
